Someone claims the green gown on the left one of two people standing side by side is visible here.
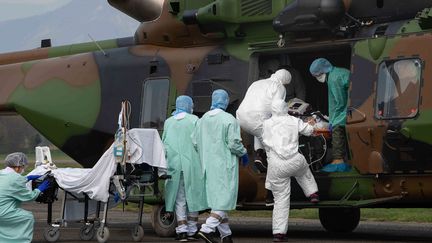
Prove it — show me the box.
[162,114,207,212]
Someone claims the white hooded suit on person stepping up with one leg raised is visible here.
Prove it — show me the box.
[263,99,318,234]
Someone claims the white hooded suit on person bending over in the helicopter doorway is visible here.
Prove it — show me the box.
[236,69,291,150]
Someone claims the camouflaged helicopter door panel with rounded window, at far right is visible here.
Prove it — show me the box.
[347,35,432,174]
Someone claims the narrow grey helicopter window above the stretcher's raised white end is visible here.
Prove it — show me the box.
[140,79,169,130]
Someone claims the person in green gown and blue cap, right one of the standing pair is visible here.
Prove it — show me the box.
[192,89,248,243]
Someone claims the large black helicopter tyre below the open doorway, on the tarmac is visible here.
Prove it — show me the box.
[319,208,360,233]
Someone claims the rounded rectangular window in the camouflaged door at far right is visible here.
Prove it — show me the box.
[375,59,422,119]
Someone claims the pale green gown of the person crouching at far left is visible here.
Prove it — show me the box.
[0,172,40,243]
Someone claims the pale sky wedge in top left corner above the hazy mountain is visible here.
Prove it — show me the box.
[0,0,72,22]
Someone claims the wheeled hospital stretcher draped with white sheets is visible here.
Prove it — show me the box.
[29,129,168,242]
